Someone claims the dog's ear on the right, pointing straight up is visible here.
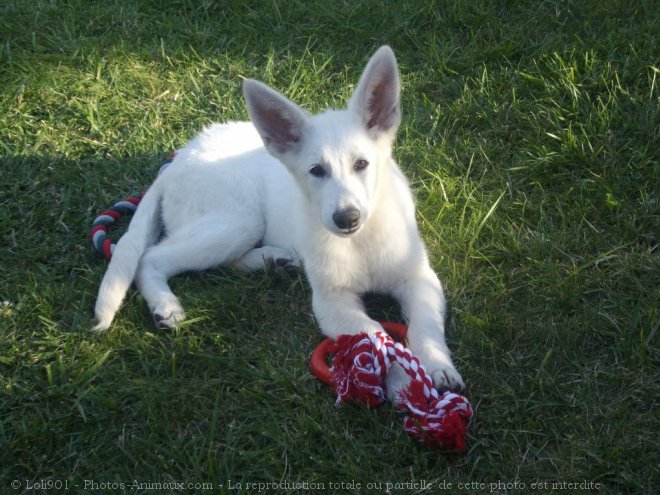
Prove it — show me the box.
[348,45,401,138]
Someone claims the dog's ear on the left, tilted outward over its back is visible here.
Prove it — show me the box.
[243,79,307,158]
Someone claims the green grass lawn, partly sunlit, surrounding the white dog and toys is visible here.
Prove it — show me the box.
[0,0,660,493]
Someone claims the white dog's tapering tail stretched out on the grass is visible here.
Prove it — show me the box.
[93,181,161,332]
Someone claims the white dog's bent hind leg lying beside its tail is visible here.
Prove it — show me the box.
[135,218,262,328]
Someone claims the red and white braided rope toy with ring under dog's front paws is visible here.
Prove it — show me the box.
[310,322,473,452]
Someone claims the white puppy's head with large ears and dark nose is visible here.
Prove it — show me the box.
[243,46,401,236]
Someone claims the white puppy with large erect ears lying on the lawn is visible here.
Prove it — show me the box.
[95,46,463,389]
